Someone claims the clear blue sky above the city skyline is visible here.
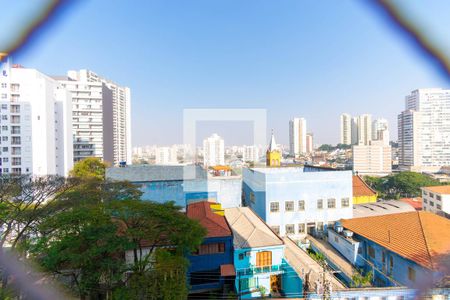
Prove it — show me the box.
[0,0,450,145]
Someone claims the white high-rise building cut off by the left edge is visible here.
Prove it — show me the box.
[0,62,73,176]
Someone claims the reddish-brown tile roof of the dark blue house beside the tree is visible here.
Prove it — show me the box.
[186,201,231,237]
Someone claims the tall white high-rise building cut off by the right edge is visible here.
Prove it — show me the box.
[398,88,450,172]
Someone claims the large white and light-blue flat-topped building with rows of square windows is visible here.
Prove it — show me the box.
[242,167,353,239]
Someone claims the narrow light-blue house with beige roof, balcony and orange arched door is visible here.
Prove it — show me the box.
[225,207,302,299]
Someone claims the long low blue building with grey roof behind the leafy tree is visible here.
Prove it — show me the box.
[106,165,242,208]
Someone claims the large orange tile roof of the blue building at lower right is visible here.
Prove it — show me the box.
[342,211,450,274]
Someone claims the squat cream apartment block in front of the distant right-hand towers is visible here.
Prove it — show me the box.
[352,141,392,175]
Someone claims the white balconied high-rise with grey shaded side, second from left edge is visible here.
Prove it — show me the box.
[57,70,132,165]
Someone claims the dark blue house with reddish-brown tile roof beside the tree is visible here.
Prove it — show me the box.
[186,201,236,295]
